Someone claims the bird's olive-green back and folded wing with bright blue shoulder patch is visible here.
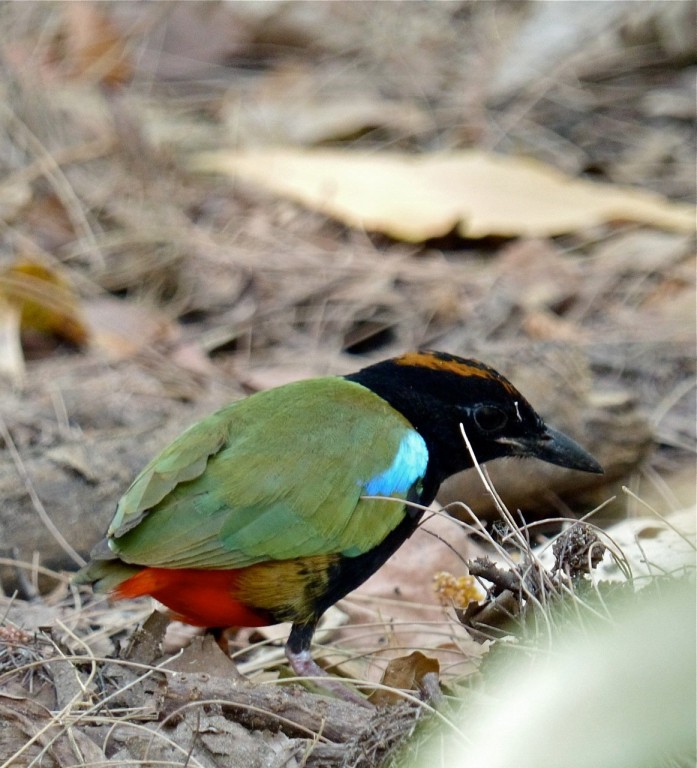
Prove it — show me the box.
[108,378,428,569]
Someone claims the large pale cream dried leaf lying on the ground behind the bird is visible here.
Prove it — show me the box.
[192,149,695,242]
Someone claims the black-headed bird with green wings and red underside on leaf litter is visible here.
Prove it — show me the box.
[75,350,603,698]
